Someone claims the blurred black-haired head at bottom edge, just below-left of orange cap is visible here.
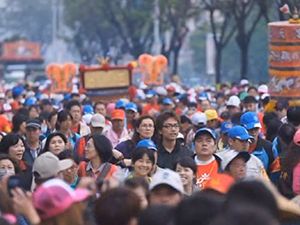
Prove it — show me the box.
[175,192,225,225]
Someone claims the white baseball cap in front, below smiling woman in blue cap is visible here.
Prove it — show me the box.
[149,169,184,194]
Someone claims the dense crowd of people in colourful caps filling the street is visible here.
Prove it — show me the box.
[0,80,300,225]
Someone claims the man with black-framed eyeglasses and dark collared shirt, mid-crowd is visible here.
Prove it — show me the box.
[156,111,193,169]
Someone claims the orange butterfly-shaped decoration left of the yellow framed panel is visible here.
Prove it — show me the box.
[46,63,77,93]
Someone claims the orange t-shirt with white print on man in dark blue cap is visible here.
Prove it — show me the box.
[196,160,219,190]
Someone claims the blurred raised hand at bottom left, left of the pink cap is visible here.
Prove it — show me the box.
[11,188,41,224]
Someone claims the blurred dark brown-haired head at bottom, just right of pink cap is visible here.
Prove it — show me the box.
[94,188,141,225]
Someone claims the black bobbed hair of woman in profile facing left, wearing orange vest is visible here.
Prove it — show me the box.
[87,133,113,163]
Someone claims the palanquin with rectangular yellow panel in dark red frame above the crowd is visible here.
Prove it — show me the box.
[79,62,133,101]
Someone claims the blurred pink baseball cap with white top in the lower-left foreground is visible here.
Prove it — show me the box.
[33,179,90,219]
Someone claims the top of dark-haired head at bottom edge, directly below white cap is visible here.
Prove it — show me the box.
[139,205,174,225]
